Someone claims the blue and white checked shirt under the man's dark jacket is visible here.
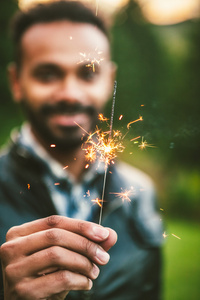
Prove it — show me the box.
[20,123,105,221]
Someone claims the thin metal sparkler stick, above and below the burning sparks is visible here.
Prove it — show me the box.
[99,80,117,225]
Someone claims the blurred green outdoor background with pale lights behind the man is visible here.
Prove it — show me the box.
[0,0,200,300]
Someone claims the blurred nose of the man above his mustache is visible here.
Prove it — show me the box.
[56,75,83,103]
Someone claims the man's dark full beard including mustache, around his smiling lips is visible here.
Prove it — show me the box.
[21,99,98,152]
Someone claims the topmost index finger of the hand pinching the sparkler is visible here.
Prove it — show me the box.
[7,215,109,242]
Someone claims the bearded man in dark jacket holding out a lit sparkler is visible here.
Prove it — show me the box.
[0,1,162,300]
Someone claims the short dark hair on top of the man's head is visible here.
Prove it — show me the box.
[10,0,109,69]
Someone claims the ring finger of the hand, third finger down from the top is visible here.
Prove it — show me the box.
[6,246,99,281]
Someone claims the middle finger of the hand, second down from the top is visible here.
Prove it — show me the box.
[1,228,109,265]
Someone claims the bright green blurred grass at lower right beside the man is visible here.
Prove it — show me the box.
[164,220,200,300]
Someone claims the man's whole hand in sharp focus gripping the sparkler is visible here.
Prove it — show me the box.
[0,216,117,300]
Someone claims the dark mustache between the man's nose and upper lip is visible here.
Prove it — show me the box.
[40,101,98,116]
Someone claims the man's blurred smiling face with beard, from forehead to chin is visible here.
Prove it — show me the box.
[12,21,114,148]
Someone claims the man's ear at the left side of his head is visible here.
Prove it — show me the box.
[7,62,22,102]
